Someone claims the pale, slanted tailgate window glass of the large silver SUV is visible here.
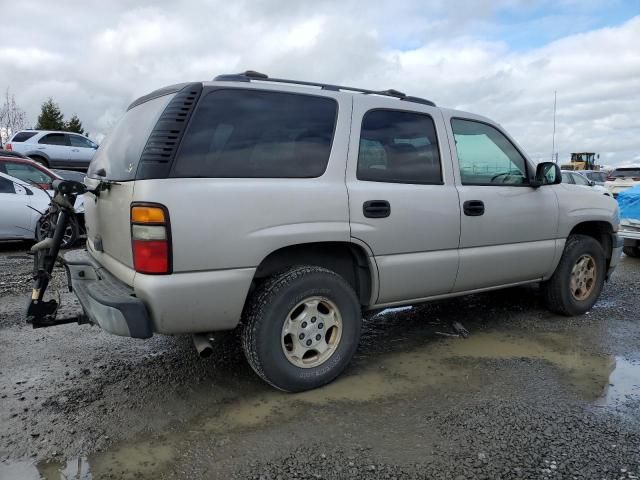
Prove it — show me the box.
[87,94,174,181]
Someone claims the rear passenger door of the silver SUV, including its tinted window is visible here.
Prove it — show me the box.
[347,95,460,304]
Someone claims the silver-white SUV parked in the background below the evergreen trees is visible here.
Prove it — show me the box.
[5,130,98,170]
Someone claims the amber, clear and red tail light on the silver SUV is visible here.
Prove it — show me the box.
[131,204,171,274]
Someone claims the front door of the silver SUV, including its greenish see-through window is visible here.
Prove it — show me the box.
[445,114,558,292]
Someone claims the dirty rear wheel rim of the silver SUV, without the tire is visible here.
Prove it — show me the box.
[281,297,342,368]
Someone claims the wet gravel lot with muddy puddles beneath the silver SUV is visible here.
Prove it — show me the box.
[0,244,640,480]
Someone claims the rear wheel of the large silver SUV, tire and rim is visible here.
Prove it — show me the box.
[242,266,361,392]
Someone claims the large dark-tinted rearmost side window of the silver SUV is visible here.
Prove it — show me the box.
[174,89,338,178]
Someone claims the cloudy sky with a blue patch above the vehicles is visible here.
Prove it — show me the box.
[0,0,640,165]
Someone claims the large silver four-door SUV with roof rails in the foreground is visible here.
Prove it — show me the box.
[63,72,621,391]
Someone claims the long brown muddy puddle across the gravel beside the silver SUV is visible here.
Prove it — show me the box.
[5,331,640,480]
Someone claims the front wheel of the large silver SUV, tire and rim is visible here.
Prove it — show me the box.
[542,235,606,316]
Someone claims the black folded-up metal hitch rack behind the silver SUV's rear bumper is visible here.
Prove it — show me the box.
[27,180,94,328]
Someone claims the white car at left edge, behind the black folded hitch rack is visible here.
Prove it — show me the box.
[0,173,50,240]
